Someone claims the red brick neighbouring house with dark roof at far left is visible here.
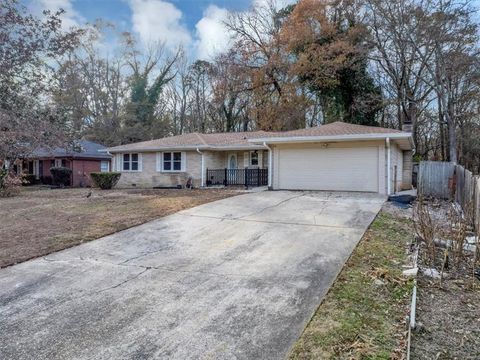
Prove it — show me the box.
[23,140,111,187]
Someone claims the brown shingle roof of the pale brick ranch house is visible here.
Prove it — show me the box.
[108,121,402,152]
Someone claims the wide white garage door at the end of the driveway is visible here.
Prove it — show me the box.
[277,147,378,192]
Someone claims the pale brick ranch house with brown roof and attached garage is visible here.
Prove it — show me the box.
[107,122,413,194]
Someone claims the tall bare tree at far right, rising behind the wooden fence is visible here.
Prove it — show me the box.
[409,0,478,163]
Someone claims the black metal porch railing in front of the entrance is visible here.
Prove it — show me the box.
[207,169,268,187]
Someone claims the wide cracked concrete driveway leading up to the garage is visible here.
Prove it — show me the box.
[0,191,384,359]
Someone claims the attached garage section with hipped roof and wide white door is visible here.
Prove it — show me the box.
[251,122,413,194]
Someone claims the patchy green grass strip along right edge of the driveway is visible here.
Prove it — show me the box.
[290,211,413,359]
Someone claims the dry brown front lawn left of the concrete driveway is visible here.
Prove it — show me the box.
[0,188,238,267]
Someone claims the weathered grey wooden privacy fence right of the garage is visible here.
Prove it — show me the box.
[417,161,480,227]
